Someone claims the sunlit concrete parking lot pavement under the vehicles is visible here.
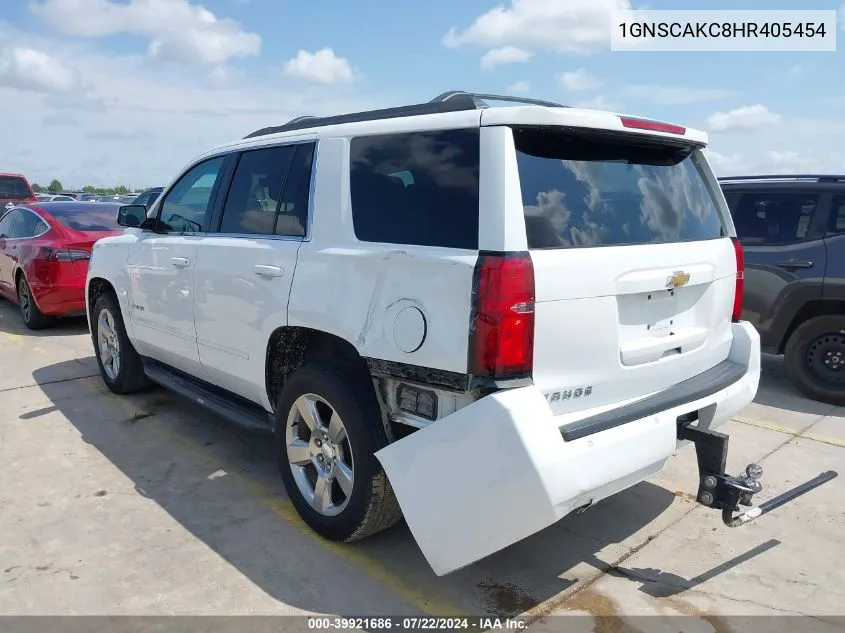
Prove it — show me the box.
[0,302,845,631]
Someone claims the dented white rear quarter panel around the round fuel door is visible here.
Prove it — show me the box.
[288,138,478,373]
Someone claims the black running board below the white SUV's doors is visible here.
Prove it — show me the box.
[144,362,273,433]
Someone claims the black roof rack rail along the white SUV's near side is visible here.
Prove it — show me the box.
[244,90,567,139]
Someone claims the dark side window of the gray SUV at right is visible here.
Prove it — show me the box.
[733,192,819,244]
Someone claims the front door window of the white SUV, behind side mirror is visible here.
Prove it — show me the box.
[159,156,226,233]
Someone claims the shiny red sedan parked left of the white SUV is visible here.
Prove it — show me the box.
[0,202,122,330]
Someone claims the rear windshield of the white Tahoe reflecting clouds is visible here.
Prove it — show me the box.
[514,129,725,249]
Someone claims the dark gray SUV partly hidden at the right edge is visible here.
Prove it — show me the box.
[719,175,845,405]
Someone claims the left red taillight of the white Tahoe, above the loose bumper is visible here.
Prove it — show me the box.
[469,252,534,379]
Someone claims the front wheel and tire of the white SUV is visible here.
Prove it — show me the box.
[91,292,150,394]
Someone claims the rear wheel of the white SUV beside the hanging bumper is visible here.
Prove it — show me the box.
[275,362,402,542]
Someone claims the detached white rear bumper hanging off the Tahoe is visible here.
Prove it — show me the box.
[376,323,760,576]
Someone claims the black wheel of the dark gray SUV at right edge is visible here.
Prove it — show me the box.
[784,315,845,406]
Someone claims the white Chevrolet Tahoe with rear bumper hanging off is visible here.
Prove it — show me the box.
[86,92,760,575]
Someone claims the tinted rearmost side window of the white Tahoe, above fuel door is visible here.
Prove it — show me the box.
[350,128,480,250]
